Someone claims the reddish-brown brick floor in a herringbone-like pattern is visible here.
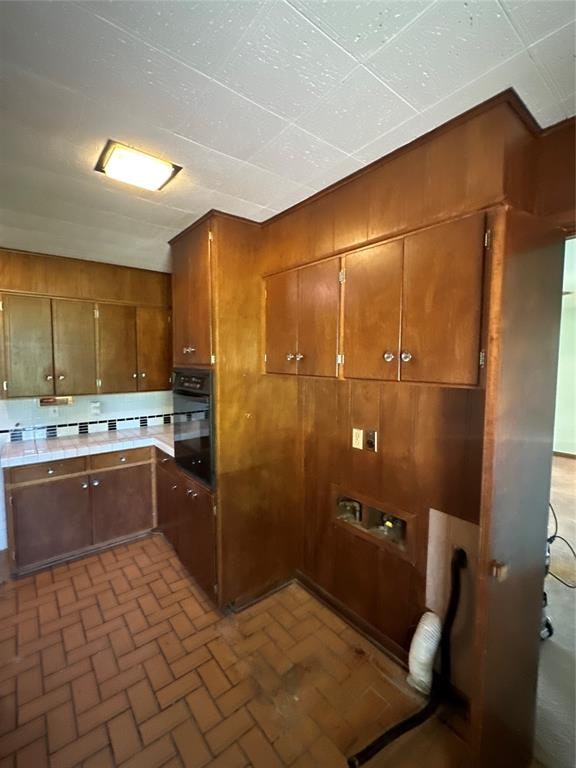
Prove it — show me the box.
[0,536,460,768]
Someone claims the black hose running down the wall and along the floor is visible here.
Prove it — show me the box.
[348,549,467,768]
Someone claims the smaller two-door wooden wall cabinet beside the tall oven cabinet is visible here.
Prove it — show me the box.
[265,258,340,376]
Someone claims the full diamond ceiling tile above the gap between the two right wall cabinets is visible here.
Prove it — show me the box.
[299,67,416,154]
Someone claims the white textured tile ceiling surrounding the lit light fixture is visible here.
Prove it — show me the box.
[0,0,576,270]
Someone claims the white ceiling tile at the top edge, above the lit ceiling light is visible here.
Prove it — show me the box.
[83,0,264,72]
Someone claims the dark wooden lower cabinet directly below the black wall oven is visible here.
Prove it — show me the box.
[156,456,217,599]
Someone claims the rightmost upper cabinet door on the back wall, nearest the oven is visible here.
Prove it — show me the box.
[136,307,171,392]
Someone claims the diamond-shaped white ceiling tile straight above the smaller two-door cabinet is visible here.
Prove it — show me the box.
[250,125,354,184]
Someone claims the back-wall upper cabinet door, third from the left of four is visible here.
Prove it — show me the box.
[98,304,138,392]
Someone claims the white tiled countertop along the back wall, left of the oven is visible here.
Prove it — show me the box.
[0,425,174,467]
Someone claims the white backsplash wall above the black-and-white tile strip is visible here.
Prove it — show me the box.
[0,392,172,550]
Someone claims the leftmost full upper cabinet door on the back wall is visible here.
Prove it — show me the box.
[2,294,54,397]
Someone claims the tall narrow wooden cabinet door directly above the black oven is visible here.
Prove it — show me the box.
[172,222,212,367]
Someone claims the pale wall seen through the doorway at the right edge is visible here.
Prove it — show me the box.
[554,239,576,454]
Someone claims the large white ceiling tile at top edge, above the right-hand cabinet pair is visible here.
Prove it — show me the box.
[368,0,523,109]
